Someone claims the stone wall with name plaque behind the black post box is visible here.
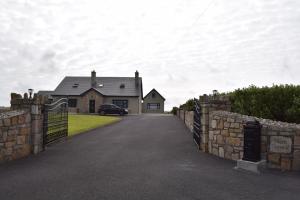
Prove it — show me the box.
[208,111,300,170]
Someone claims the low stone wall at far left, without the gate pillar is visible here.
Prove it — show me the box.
[0,110,31,162]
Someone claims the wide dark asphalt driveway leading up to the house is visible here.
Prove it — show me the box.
[0,115,300,200]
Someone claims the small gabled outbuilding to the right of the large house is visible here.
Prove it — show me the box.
[143,89,165,113]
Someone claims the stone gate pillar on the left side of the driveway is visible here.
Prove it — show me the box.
[10,93,46,154]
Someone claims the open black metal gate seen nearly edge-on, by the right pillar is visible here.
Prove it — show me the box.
[193,99,202,148]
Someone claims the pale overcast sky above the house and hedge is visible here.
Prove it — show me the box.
[0,0,300,110]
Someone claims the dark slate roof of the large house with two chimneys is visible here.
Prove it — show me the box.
[52,76,143,96]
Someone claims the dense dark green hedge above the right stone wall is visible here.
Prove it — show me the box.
[229,85,300,123]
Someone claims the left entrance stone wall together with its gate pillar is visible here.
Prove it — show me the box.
[0,93,47,162]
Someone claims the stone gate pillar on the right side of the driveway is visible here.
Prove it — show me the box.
[199,94,231,152]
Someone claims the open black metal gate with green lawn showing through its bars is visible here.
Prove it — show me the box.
[43,98,68,146]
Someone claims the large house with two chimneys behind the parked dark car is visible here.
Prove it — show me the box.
[39,71,143,114]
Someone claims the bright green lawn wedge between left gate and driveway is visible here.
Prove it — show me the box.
[68,114,121,137]
